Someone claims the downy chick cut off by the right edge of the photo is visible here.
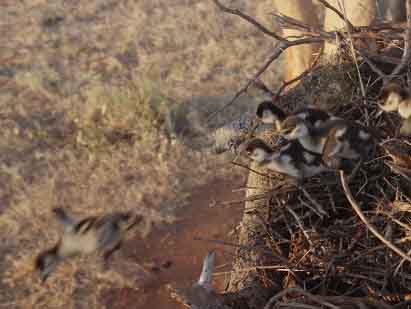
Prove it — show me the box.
[380,83,411,136]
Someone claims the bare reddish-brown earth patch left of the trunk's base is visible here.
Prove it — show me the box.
[103,181,243,309]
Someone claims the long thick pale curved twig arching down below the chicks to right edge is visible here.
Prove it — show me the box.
[340,170,411,262]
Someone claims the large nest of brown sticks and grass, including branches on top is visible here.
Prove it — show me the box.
[209,1,411,309]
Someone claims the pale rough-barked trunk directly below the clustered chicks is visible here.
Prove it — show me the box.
[228,164,281,309]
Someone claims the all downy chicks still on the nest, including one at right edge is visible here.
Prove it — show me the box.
[241,83,411,180]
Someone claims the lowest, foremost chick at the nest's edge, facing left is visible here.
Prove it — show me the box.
[245,139,328,179]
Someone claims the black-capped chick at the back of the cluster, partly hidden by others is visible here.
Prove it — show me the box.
[256,101,332,131]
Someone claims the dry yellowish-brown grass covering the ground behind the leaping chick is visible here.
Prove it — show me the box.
[0,0,284,308]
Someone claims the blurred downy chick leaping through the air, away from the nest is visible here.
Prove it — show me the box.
[35,208,142,282]
